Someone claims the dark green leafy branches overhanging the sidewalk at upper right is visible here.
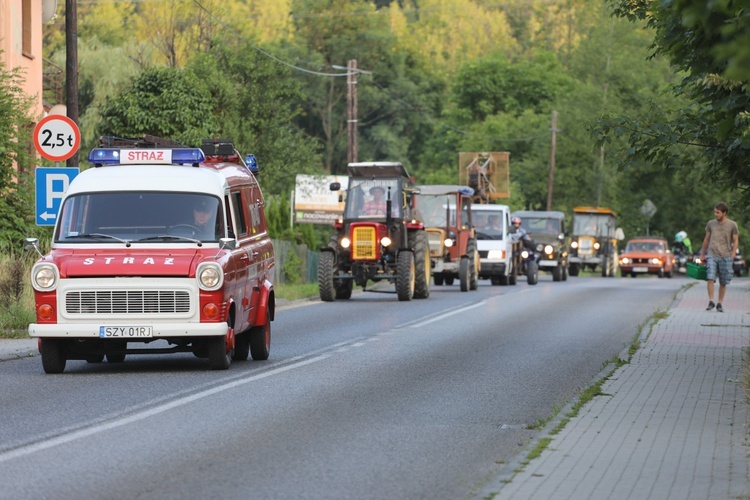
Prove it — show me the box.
[597,0,750,208]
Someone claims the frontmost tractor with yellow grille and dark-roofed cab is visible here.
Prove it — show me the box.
[318,162,431,302]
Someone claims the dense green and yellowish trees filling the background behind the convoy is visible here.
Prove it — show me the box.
[0,0,750,252]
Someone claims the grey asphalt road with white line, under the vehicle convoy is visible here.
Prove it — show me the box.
[0,274,688,499]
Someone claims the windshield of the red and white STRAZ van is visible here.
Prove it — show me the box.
[55,191,224,244]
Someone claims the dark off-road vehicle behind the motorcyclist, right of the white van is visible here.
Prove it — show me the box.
[511,210,570,281]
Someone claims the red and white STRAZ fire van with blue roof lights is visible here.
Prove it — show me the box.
[26,136,275,373]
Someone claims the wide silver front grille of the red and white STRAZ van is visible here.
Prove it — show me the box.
[65,290,190,314]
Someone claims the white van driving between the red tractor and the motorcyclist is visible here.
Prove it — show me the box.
[471,204,521,286]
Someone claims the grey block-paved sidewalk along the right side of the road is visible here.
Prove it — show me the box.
[476,279,750,500]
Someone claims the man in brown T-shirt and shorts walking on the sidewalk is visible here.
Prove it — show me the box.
[700,202,739,312]
